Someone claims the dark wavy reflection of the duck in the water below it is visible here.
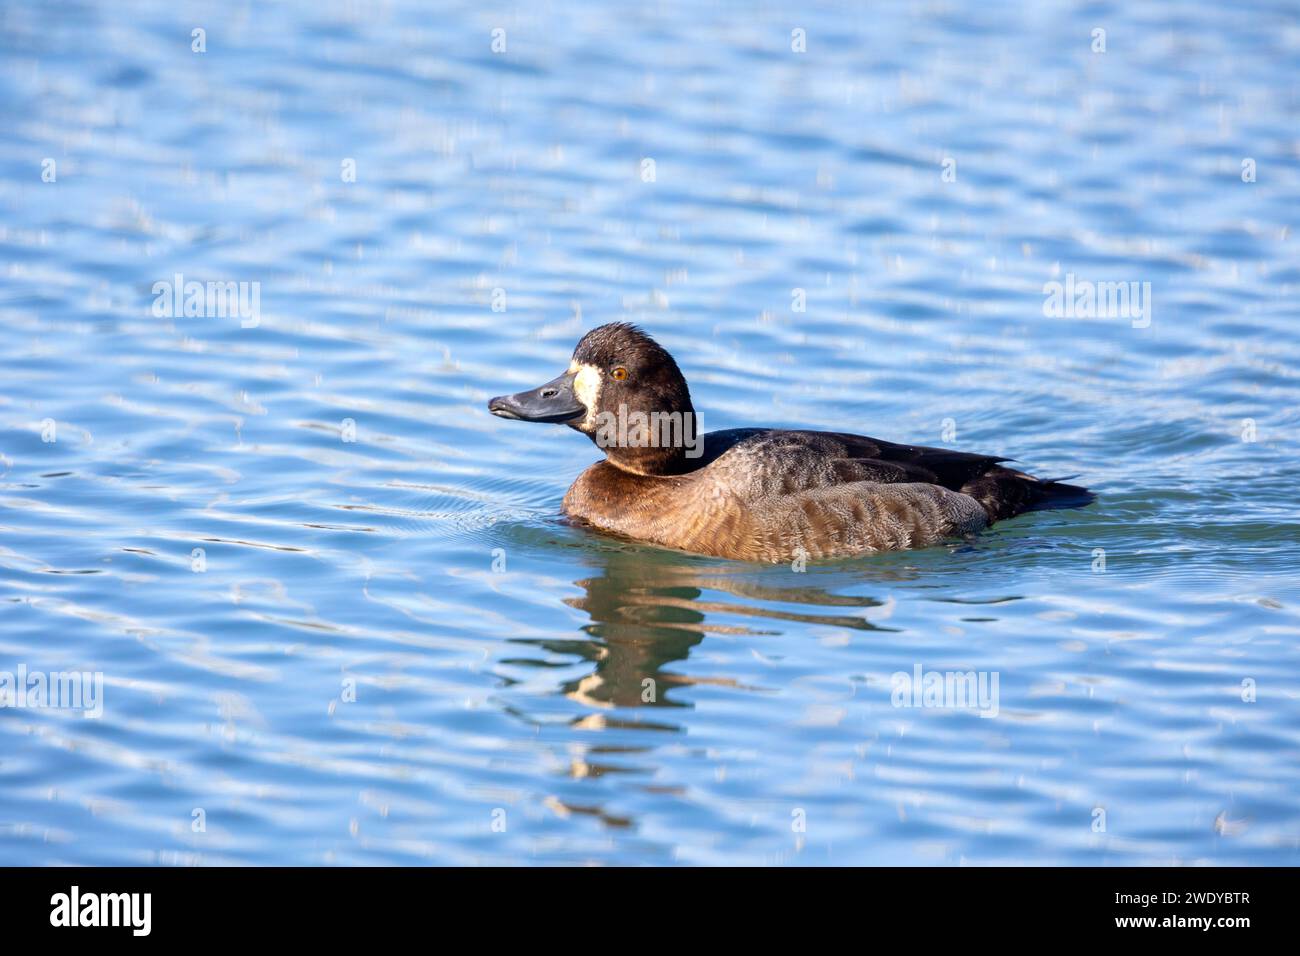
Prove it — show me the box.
[512,545,897,712]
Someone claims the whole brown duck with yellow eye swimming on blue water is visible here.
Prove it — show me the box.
[488,323,1095,563]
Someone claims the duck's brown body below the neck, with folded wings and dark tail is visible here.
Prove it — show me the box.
[564,428,1087,562]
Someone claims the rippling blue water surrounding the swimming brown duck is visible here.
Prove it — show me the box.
[0,0,1300,865]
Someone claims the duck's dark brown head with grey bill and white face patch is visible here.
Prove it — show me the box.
[488,323,699,475]
